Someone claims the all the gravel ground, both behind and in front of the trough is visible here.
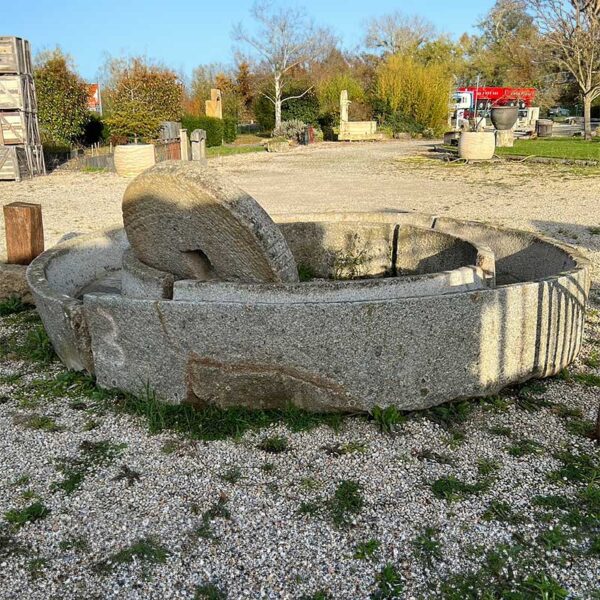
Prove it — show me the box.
[0,143,600,600]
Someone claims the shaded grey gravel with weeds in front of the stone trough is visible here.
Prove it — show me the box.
[0,310,600,600]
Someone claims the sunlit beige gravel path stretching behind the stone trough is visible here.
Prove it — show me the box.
[0,142,600,281]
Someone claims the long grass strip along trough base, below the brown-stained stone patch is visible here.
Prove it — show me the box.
[112,386,344,441]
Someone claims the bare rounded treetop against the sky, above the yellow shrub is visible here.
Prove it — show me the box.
[365,12,436,54]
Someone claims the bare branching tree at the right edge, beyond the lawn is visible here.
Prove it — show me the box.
[526,0,600,139]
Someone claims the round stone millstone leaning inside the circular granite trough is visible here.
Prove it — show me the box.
[123,161,298,283]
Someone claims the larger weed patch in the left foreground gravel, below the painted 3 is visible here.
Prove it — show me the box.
[52,440,127,495]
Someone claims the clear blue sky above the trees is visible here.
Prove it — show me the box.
[0,0,494,81]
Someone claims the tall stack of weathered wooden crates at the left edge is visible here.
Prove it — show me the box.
[0,36,46,181]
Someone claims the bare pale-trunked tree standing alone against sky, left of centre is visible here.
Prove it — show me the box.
[233,1,334,128]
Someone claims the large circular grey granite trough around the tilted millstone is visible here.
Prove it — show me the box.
[28,167,590,412]
